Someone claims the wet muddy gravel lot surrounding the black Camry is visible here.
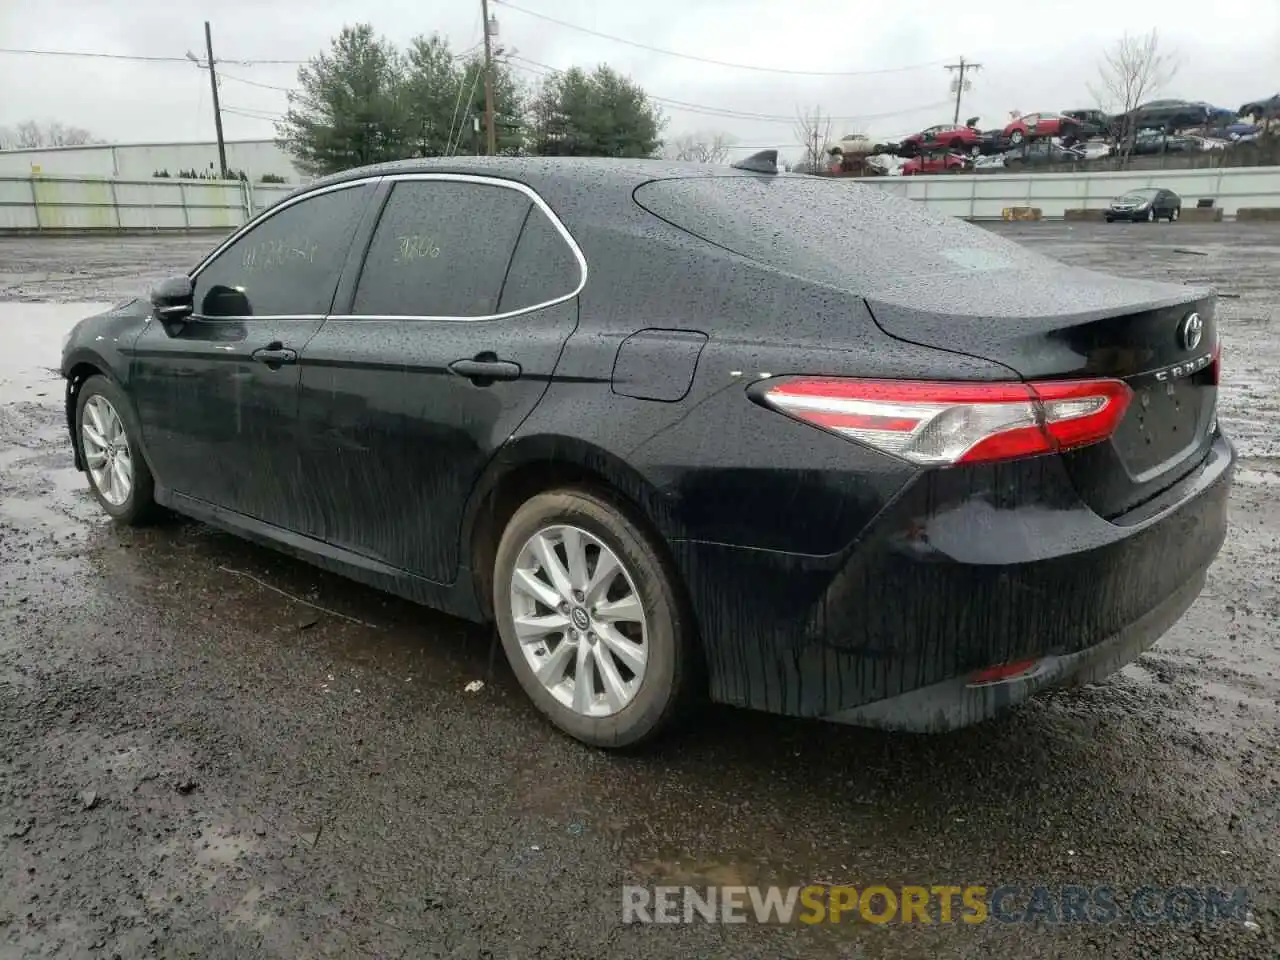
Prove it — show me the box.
[0,223,1280,960]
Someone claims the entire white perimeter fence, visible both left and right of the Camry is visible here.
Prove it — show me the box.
[0,166,1280,230]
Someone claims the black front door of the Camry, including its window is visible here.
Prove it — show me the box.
[129,184,374,532]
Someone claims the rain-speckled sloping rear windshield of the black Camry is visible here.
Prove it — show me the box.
[635,175,1041,293]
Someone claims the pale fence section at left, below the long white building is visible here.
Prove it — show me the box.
[0,175,297,230]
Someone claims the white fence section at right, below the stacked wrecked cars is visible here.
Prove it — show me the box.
[858,166,1280,220]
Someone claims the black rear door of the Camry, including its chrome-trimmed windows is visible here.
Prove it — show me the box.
[300,174,585,582]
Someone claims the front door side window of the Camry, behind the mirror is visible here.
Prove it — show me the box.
[193,184,372,317]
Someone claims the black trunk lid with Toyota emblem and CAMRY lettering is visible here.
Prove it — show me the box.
[868,271,1217,518]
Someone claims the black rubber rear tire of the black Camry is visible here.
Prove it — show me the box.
[493,488,699,749]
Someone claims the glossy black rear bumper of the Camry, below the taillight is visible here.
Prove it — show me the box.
[672,435,1235,730]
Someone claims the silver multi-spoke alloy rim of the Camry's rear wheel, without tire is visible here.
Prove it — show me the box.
[509,525,649,717]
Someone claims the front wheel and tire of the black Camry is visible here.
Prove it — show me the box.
[76,374,159,526]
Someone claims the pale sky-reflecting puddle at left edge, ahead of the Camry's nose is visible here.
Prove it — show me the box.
[0,303,111,403]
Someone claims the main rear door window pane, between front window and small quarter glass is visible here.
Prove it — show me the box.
[351,180,532,317]
